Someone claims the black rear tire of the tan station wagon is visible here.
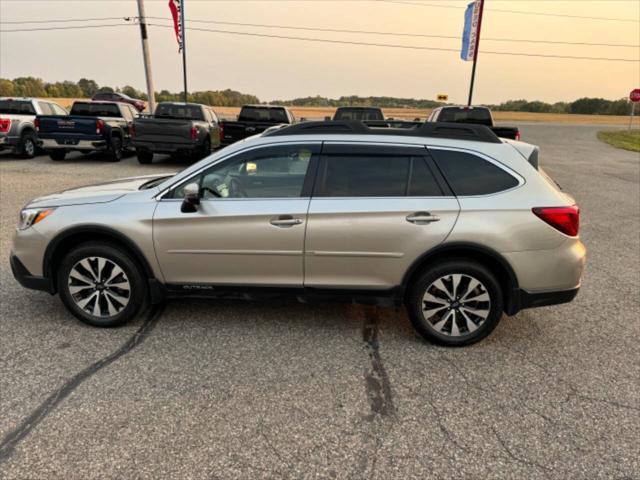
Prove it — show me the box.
[406,259,503,347]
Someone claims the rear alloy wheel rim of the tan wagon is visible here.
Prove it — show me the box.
[422,273,491,337]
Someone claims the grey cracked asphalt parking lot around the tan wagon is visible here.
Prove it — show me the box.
[0,124,640,479]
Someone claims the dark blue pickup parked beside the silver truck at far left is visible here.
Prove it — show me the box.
[34,102,138,162]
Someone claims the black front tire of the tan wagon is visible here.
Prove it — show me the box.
[56,242,149,328]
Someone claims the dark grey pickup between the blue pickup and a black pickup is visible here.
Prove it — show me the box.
[132,102,220,163]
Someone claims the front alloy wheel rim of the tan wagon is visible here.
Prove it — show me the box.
[68,257,131,318]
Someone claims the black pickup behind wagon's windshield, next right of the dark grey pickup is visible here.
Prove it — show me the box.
[220,105,296,147]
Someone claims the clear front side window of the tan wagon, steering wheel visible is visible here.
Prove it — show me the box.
[173,145,319,200]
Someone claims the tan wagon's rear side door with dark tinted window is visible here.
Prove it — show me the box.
[304,142,459,289]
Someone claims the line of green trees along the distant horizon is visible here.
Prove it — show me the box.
[0,77,631,115]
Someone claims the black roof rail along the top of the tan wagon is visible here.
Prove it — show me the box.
[264,120,502,143]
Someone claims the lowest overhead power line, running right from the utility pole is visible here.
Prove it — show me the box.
[147,23,640,62]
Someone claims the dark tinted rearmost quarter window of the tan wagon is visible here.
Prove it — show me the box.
[430,150,519,195]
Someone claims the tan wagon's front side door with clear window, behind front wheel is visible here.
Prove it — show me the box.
[153,143,320,288]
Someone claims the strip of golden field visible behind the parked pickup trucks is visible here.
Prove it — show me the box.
[50,98,640,127]
